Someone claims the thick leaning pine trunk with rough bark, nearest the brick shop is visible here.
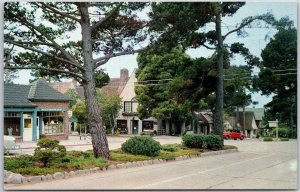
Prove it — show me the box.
[79,3,110,159]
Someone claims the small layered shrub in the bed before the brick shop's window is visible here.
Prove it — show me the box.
[33,138,66,167]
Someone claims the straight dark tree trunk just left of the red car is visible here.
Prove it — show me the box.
[214,8,224,144]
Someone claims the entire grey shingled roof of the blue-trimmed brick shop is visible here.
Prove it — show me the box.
[4,79,70,107]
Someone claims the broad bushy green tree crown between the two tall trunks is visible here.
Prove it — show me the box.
[135,46,215,126]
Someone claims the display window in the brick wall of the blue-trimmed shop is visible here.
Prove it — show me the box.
[43,112,64,134]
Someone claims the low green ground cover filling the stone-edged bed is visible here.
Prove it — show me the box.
[4,144,236,175]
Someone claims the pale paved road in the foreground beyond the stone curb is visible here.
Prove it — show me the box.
[5,140,297,190]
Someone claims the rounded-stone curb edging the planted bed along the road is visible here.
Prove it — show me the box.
[3,149,238,184]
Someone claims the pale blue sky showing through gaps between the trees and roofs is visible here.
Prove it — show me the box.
[9,2,297,107]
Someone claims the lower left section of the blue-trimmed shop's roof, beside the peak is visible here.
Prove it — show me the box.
[4,84,36,107]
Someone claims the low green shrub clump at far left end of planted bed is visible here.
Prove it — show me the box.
[4,155,35,171]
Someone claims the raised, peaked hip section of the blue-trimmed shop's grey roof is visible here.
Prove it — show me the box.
[28,78,70,101]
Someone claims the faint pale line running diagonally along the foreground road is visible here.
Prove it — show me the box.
[134,155,273,189]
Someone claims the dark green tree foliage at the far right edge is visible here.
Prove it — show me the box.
[253,25,297,127]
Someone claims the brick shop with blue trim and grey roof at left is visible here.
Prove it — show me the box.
[4,78,70,141]
